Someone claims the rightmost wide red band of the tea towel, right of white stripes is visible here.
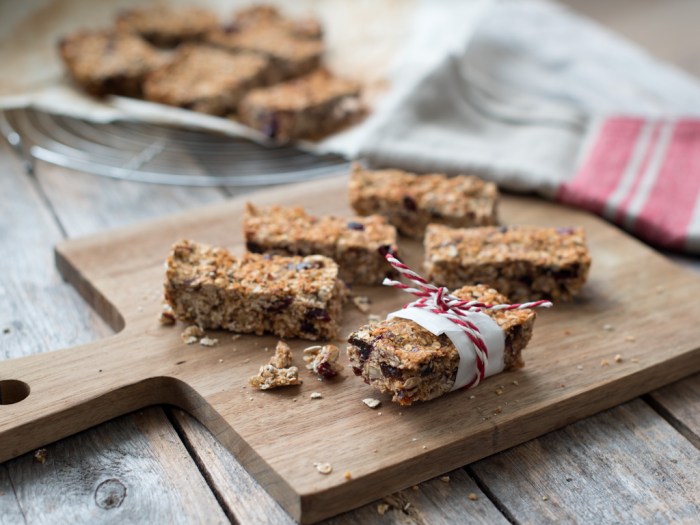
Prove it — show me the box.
[635,119,700,250]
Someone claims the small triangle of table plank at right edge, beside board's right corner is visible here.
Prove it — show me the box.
[647,374,700,449]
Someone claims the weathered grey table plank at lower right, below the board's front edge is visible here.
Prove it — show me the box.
[470,400,700,524]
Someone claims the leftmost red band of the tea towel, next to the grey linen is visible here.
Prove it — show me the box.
[557,117,645,214]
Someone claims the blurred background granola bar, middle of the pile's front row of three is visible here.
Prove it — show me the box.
[144,44,269,115]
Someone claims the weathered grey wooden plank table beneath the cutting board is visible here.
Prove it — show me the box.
[0,1,700,524]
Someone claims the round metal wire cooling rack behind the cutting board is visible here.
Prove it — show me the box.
[0,108,348,186]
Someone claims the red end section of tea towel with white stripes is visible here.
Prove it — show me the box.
[557,117,700,253]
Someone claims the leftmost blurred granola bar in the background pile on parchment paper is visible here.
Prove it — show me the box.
[59,31,166,97]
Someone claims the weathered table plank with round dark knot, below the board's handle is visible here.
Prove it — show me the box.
[8,408,228,524]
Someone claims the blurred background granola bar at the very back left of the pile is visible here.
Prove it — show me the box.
[117,6,218,47]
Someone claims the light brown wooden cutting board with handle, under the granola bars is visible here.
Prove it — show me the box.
[0,177,700,523]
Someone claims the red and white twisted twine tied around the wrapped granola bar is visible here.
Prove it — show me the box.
[382,253,552,388]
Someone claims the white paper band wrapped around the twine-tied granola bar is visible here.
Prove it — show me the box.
[387,307,505,390]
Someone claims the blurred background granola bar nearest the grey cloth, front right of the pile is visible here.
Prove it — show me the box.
[239,70,364,142]
